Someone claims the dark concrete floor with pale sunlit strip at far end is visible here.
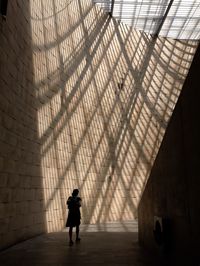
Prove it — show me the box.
[0,222,161,266]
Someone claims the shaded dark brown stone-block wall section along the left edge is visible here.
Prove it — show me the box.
[0,1,46,249]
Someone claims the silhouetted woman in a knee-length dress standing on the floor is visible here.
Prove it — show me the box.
[66,189,81,245]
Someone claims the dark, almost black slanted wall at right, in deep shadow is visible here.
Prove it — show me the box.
[139,47,200,265]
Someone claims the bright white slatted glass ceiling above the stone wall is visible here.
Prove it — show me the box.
[93,0,200,40]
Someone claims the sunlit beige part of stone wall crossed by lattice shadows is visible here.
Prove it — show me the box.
[30,0,196,231]
